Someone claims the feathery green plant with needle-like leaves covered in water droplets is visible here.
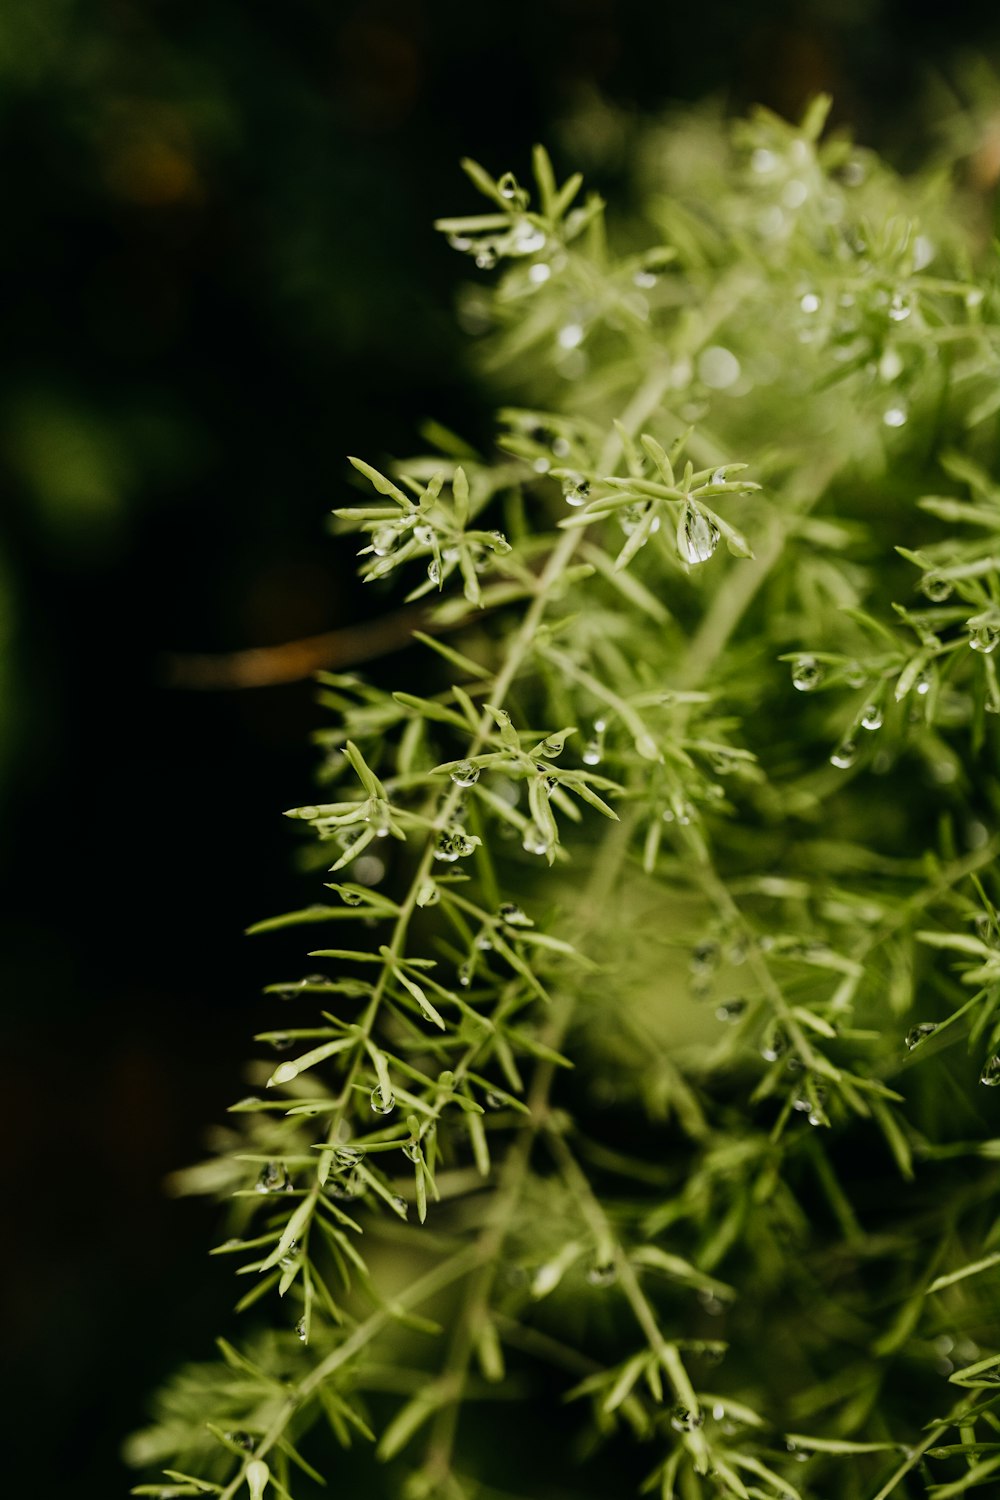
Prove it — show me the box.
[129,101,1000,1500]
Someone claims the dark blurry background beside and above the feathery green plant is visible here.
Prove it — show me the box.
[0,0,1000,1500]
